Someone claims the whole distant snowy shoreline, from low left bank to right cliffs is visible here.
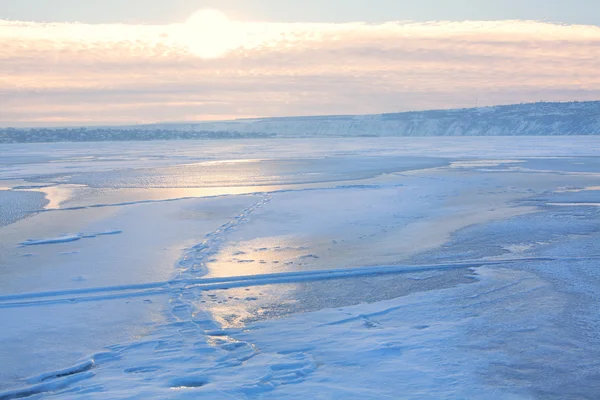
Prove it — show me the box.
[0,101,600,143]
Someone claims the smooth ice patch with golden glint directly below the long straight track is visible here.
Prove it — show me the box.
[196,269,474,328]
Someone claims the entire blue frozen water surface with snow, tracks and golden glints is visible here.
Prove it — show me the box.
[0,136,600,400]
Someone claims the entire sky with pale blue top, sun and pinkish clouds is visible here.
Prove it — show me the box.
[0,0,600,126]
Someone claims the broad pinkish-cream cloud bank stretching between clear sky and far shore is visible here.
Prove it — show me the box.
[0,15,600,125]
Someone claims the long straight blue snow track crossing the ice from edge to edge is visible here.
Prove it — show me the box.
[0,256,600,308]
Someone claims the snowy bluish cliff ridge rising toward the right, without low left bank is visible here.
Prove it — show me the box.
[160,102,600,137]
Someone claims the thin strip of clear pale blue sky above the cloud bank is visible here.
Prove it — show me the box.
[0,0,600,25]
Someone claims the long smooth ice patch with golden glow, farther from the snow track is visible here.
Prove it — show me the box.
[62,156,447,188]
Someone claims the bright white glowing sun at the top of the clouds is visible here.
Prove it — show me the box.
[183,10,243,58]
